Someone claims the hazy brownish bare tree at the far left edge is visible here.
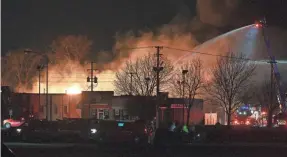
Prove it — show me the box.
[1,49,41,92]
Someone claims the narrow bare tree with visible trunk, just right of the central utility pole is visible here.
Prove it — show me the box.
[171,58,203,125]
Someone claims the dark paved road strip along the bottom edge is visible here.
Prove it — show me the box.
[3,143,287,157]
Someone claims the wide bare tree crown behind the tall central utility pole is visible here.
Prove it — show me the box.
[114,53,173,96]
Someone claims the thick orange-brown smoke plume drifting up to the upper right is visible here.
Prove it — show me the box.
[102,0,264,70]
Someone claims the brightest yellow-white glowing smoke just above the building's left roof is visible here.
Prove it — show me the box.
[26,61,114,94]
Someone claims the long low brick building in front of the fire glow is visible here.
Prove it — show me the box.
[10,91,204,123]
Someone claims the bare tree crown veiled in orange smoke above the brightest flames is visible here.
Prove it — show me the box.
[49,35,92,81]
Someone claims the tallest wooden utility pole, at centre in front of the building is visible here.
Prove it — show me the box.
[153,46,163,128]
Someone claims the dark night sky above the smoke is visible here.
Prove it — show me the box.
[1,0,286,54]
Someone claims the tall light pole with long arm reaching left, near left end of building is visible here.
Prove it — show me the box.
[24,50,52,120]
